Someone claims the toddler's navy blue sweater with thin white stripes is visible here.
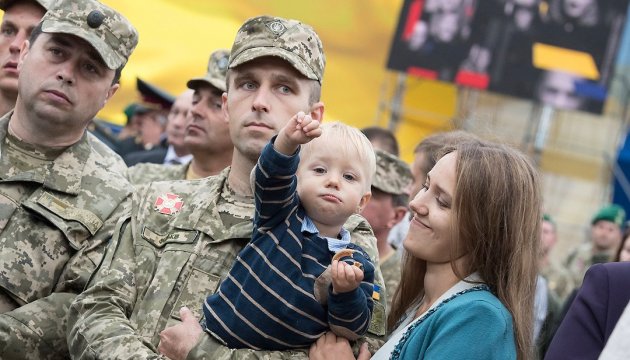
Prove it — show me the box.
[204,140,374,350]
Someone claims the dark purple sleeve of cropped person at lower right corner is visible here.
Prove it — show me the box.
[545,265,609,359]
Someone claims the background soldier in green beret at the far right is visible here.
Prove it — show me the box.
[565,204,626,287]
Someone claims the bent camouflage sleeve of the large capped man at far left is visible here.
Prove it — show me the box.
[0,197,130,359]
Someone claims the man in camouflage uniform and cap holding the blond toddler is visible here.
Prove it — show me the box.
[68,16,385,359]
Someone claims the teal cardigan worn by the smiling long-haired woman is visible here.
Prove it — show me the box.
[392,288,516,360]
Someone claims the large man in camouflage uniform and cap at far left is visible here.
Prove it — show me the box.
[0,0,137,359]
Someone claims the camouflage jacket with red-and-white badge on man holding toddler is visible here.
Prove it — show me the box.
[68,168,385,359]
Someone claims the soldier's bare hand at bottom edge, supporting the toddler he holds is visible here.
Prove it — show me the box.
[158,307,203,360]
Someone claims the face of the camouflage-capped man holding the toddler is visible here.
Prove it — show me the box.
[223,56,324,161]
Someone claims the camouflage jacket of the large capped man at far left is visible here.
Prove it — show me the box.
[0,113,131,359]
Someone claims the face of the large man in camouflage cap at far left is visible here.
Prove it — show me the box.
[16,33,118,132]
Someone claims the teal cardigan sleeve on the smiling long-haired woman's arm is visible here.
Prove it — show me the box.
[414,300,516,360]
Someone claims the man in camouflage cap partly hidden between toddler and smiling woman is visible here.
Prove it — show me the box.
[361,149,412,309]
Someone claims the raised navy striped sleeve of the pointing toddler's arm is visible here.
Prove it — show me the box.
[254,138,299,231]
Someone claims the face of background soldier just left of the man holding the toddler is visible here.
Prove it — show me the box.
[184,85,233,153]
